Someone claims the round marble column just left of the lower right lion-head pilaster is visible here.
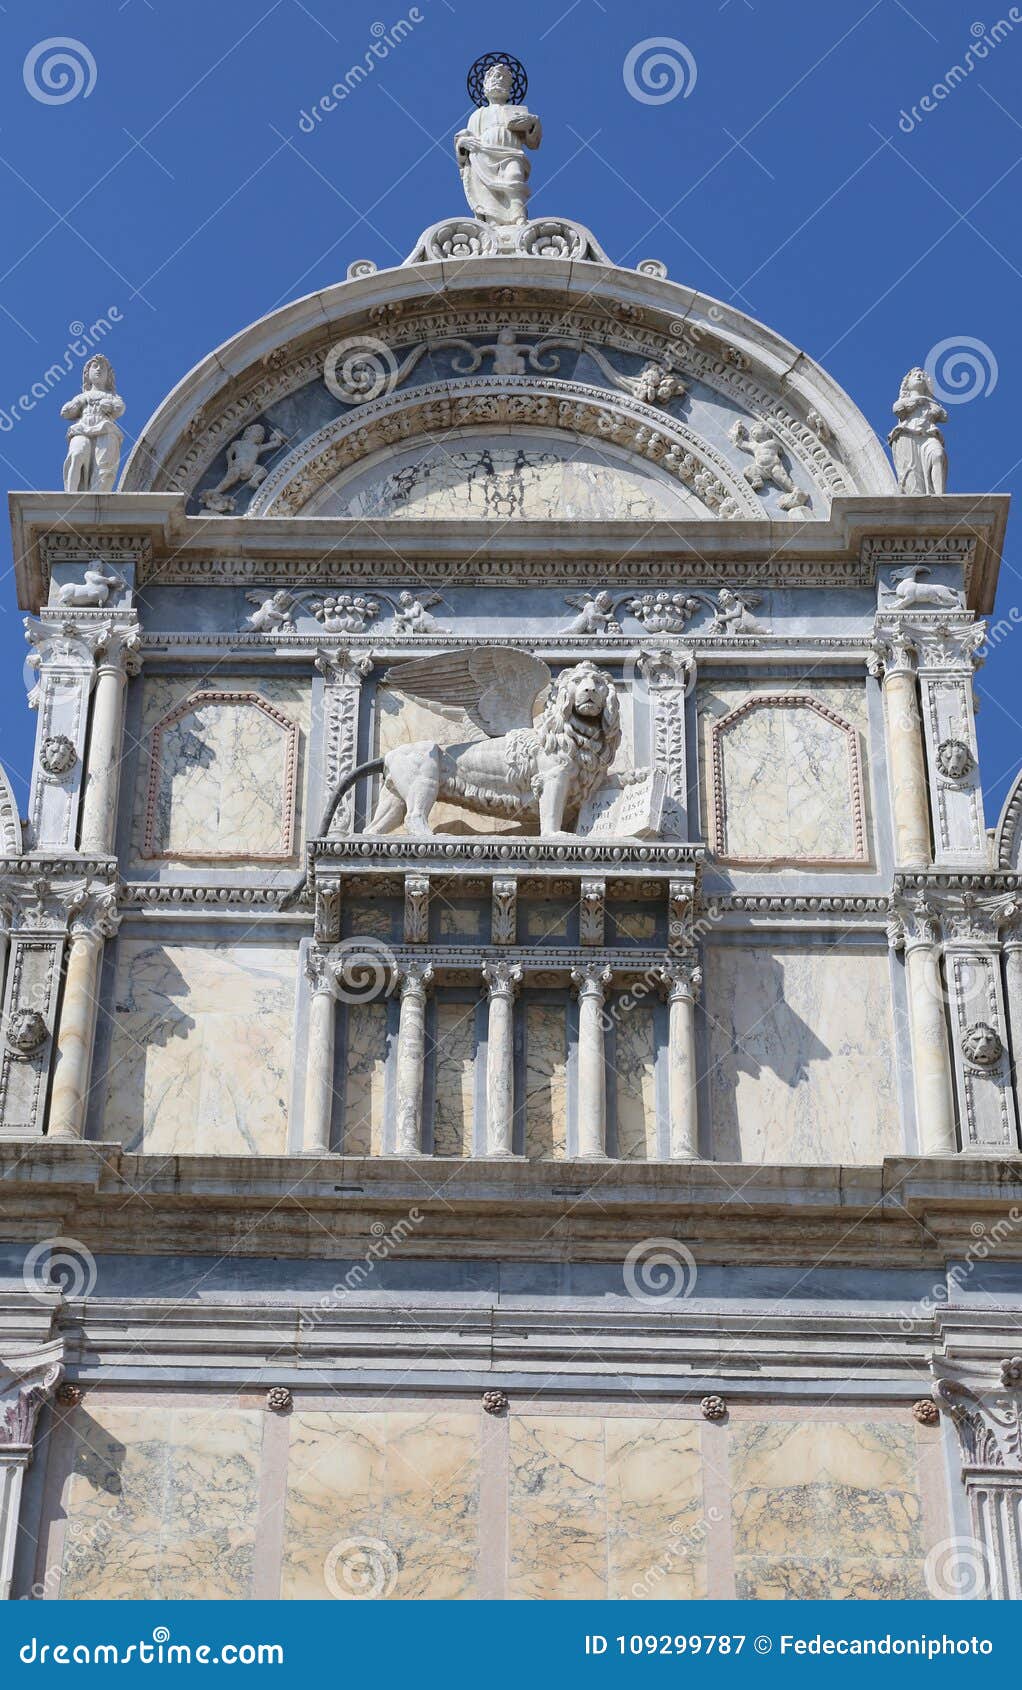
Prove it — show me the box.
[892,897,958,1156]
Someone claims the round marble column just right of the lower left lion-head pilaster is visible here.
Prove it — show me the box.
[49,887,120,1139]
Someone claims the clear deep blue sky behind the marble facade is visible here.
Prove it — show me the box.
[0,0,1022,823]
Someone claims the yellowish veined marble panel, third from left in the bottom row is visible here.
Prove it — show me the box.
[508,1415,704,1600]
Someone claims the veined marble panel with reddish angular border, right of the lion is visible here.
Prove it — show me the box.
[699,681,872,865]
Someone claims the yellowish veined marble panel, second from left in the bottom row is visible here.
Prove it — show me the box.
[280,1409,480,1600]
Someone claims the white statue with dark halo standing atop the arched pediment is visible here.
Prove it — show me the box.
[454,56,542,223]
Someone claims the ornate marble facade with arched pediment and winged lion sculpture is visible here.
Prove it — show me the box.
[0,98,1022,1600]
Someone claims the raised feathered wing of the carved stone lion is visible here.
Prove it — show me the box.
[387,646,551,739]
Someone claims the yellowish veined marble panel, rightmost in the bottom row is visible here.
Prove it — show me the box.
[731,1421,927,1600]
